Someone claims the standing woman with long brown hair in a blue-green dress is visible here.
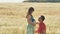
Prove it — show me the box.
[26,7,35,34]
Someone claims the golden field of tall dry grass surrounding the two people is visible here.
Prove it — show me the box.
[0,3,60,34]
